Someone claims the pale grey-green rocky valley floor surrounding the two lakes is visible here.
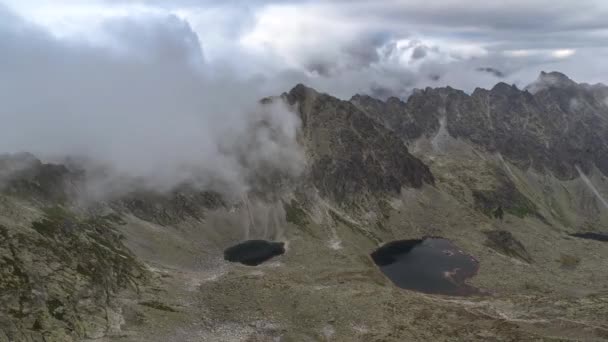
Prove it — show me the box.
[100,138,608,341]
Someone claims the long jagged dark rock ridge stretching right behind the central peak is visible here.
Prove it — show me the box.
[351,72,608,180]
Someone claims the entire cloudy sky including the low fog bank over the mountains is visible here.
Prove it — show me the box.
[0,0,608,195]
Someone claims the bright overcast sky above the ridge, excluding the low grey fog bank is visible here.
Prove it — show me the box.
[4,0,608,97]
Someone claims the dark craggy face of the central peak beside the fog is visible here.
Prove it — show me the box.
[284,85,434,203]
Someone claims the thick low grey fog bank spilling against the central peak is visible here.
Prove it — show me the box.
[0,6,303,200]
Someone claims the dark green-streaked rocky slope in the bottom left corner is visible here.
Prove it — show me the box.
[0,206,147,340]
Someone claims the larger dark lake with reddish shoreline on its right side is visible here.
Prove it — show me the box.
[371,238,480,296]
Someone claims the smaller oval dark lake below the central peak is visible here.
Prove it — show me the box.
[224,240,285,266]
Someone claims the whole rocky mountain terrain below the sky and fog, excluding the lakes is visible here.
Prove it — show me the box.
[0,72,608,342]
